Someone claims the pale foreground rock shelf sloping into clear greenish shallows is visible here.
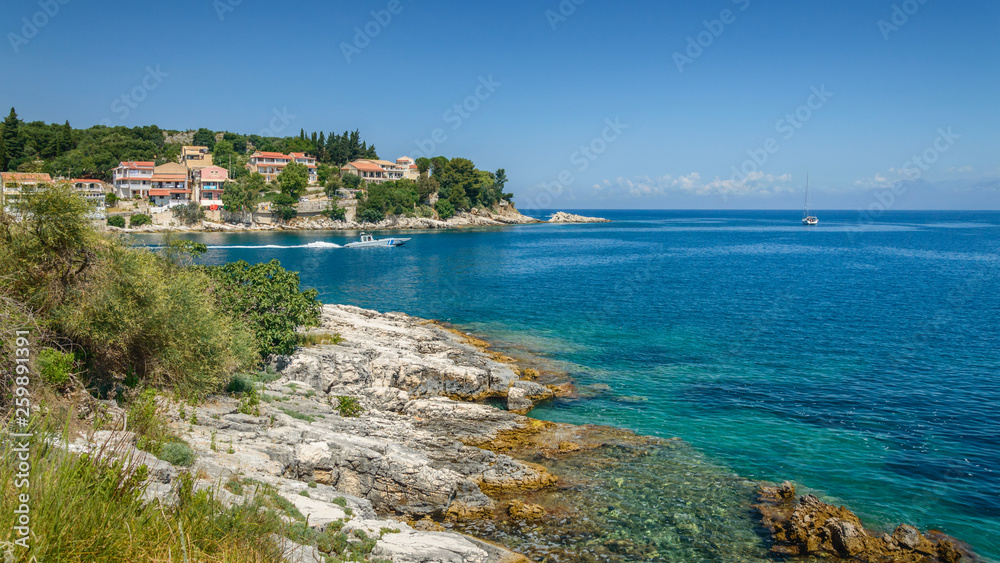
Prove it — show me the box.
[76,305,973,563]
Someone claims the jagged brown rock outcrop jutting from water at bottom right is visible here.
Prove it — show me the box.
[753,482,976,563]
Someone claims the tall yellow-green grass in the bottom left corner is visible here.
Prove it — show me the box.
[0,420,282,562]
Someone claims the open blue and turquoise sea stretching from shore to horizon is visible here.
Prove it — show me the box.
[148,211,1000,559]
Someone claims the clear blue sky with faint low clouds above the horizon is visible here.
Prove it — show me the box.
[0,0,1000,210]
